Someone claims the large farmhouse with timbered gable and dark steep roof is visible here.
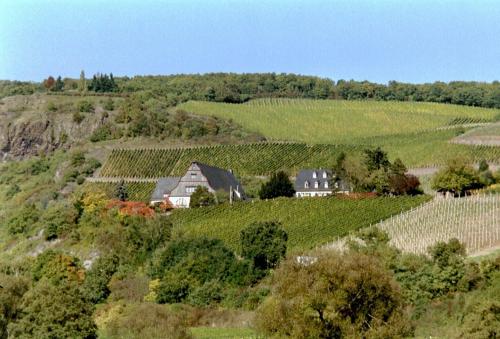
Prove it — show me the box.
[151,162,245,207]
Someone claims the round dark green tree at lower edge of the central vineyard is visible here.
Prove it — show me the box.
[240,221,288,270]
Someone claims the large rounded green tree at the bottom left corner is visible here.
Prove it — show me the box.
[9,279,97,339]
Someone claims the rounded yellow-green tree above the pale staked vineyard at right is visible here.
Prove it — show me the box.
[432,159,483,196]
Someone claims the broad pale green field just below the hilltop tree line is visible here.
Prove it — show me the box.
[179,99,499,144]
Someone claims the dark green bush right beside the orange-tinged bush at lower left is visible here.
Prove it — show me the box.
[82,255,119,304]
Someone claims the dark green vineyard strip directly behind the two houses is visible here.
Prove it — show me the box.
[100,143,354,178]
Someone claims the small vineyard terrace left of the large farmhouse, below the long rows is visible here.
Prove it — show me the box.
[83,181,156,203]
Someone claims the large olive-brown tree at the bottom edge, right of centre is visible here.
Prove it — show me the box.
[256,251,413,338]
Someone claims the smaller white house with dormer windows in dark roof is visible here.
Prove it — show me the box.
[295,169,349,197]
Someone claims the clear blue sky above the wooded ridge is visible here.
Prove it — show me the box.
[0,0,500,83]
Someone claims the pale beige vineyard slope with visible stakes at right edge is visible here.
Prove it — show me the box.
[378,194,500,254]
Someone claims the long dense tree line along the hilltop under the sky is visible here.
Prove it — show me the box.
[4,71,500,108]
